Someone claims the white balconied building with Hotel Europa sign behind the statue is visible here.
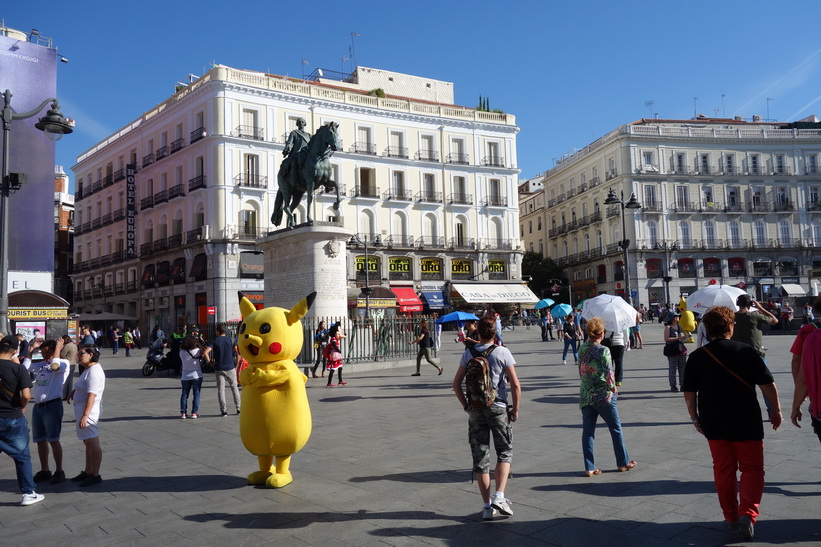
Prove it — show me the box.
[72,66,522,329]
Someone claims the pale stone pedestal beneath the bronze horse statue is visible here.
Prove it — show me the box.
[257,224,353,317]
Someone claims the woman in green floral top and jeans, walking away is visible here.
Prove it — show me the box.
[579,317,636,477]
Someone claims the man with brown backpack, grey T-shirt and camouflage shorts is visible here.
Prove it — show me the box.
[453,315,522,520]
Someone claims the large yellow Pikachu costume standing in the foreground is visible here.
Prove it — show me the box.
[237,292,316,488]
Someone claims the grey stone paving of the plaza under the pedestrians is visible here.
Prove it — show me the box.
[0,324,821,547]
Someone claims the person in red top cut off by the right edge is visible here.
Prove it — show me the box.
[790,298,821,441]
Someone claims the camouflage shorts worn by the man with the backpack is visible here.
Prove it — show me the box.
[468,405,513,473]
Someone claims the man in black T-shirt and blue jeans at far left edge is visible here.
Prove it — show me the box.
[0,336,45,505]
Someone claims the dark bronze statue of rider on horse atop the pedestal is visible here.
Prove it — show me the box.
[271,122,340,228]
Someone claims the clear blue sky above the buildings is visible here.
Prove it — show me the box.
[0,0,821,186]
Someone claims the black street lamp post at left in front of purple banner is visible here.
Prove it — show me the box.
[0,89,73,334]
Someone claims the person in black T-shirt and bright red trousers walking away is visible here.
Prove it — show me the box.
[682,306,781,540]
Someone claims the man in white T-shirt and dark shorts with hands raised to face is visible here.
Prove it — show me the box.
[23,338,71,484]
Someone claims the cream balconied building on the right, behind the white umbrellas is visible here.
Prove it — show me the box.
[520,117,821,304]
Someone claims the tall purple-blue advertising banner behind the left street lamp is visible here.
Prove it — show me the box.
[0,36,57,280]
